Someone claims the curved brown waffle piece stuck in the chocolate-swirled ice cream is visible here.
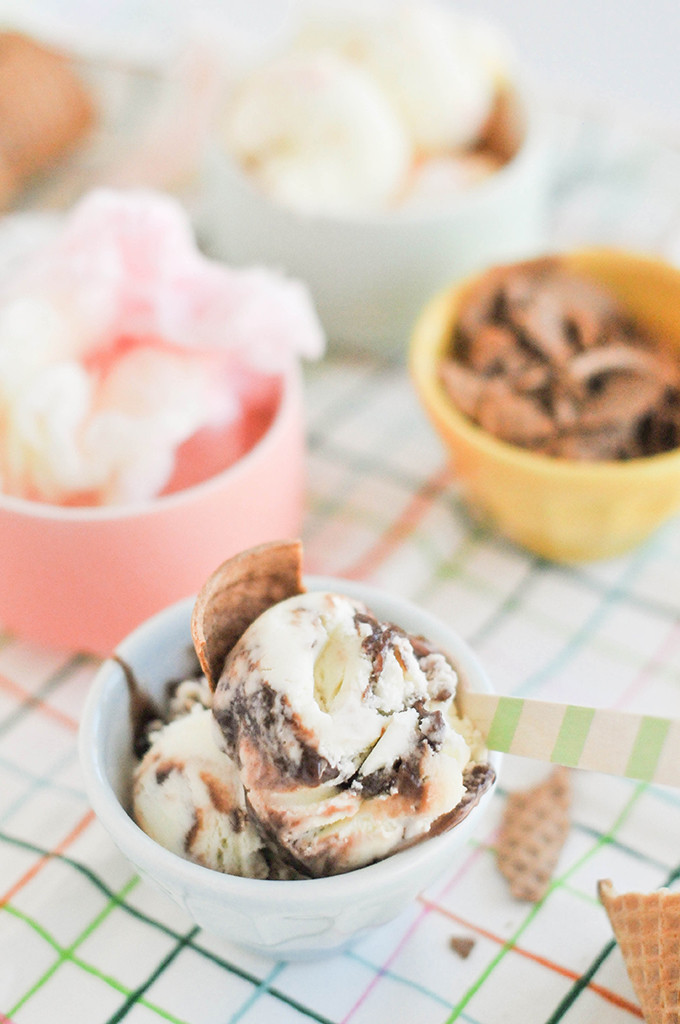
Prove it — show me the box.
[192,541,304,690]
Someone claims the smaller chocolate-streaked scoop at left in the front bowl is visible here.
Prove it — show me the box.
[133,706,269,879]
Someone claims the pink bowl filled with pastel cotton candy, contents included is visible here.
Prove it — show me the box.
[0,191,323,654]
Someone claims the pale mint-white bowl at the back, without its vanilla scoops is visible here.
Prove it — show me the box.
[197,84,550,354]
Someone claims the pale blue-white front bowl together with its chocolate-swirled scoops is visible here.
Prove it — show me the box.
[80,549,499,958]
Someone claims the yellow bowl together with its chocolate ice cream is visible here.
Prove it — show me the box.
[410,249,680,561]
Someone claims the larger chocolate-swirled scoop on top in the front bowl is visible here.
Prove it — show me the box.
[213,592,493,876]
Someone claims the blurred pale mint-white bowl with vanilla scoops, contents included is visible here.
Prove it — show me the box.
[199,0,549,353]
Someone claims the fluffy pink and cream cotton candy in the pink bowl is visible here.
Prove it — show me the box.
[0,189,324,505]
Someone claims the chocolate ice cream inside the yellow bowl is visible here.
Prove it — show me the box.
[440,257,680,460]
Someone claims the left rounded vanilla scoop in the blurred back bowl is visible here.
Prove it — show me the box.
[224,50,412,213]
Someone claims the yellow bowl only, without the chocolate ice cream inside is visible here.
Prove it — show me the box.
[410,249,680,561]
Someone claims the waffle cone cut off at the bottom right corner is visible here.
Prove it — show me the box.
[597,879,680,1024]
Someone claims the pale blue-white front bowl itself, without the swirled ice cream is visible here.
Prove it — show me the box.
[80,578,500,959]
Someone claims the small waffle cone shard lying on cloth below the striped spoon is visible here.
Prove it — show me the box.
[497,768,571,902]
